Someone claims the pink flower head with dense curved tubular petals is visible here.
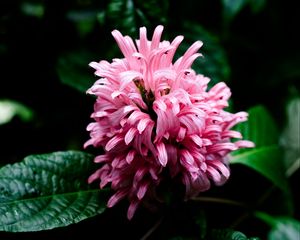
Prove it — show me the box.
[85,26,254,219]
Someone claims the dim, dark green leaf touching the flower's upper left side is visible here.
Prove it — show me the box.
[56,51,95,92]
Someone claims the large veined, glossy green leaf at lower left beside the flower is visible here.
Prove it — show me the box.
[0,151,106,232]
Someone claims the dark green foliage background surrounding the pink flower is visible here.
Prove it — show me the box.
[0,0,300,240]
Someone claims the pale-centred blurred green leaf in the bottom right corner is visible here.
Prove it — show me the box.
[256,212,300,240]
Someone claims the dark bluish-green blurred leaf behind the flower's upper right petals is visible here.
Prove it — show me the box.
[177,22,230,86]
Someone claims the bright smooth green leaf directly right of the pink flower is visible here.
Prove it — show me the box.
[230,106,289,193]
